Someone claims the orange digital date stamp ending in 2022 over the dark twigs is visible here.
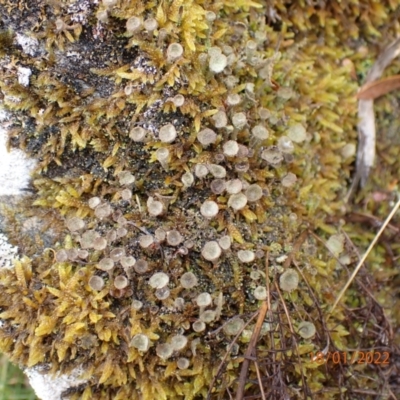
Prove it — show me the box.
[310,351,390,365]
